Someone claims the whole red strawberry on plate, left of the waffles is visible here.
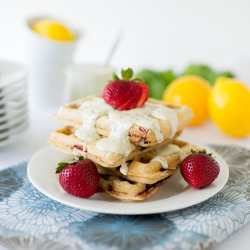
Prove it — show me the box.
[56,159,99,198]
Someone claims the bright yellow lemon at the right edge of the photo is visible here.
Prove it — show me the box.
[209,77,250,137]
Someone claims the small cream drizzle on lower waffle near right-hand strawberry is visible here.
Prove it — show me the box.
[150,144,187,169]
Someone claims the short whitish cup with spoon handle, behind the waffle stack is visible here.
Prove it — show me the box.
[63,64,114,103]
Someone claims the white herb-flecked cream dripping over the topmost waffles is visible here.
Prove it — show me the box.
[75,97,182,175]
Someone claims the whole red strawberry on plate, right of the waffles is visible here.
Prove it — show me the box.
[180,150,220,189]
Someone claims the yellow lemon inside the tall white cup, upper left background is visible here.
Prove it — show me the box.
[32,19,74,41]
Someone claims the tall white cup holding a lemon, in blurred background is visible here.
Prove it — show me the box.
[26,17,80,106]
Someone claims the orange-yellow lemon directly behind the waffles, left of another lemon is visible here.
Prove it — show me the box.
[163,75,211,125]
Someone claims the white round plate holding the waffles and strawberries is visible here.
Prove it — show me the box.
[27,144,229,214]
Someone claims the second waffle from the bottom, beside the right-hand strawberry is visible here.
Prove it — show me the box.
[97,140,200,184]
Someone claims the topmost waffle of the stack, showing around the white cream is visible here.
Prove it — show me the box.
[54,96,193,147]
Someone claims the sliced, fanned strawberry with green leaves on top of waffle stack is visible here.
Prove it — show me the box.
[102,68,149,111]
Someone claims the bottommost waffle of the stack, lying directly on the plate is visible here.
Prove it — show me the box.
[99,174,167,202]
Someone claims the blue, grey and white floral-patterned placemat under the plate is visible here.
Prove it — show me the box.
[0,146,250,250]
